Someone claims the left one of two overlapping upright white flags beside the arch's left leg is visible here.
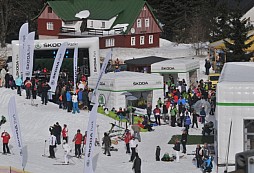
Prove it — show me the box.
[18,23,28,80]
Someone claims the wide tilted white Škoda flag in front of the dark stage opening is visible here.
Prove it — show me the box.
[49,42,68,92]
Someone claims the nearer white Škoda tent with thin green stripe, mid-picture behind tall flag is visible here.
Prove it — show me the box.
[88,71,163,109]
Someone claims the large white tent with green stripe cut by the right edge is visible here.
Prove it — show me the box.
[215,62,254,164]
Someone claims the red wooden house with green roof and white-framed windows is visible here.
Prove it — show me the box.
[36,0,162,49]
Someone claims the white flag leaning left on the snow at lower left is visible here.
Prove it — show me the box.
[8,96,25,170]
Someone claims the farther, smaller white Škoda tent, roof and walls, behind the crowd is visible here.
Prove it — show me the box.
[151,57,199,86]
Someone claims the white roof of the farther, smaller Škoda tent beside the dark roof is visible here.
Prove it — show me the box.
[151,57,199,73]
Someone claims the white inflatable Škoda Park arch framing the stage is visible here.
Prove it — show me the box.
[12,37,100,79]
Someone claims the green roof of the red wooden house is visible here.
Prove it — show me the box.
[38,0,160,33]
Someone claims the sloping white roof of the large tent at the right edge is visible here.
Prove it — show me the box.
[219,62,254,83]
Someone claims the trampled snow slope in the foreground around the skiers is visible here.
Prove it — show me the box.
[0,88,216,173]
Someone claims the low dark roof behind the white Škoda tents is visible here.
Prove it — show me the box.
[124,56,169,65]
